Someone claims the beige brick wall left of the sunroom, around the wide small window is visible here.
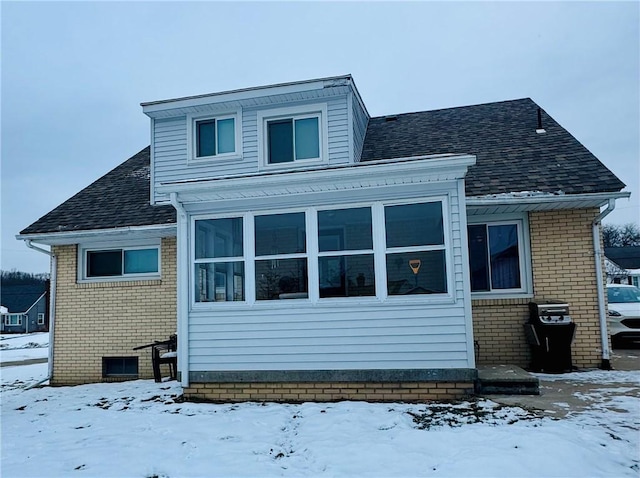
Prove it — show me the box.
[51,238,176,385]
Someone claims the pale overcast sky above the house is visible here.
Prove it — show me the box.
[1,1,640,272]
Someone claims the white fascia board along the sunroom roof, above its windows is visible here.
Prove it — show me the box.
[157,154,476,203]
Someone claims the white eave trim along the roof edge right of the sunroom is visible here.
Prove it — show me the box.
[466,191,631,210]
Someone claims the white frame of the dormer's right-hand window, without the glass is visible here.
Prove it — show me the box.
[258,103,329,170]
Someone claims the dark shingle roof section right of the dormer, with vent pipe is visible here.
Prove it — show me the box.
[361,98,624,196]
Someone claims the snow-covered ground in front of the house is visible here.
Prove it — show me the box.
[0,336,640,478]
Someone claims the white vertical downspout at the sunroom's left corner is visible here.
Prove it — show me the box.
[169,193,189,388]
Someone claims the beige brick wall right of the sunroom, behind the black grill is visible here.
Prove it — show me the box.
[472,209,602,367]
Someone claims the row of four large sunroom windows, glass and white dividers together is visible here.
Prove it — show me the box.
[192,200,450,304]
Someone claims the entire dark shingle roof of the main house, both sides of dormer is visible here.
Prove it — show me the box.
[20,98,624,235]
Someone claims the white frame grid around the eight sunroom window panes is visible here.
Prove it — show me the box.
[189,195,455,311]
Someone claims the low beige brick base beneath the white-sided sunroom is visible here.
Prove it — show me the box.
[184,382,474,402]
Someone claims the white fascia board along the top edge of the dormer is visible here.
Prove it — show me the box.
[140,75,352,117]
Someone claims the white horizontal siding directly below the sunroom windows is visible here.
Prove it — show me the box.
[189,304,469,372]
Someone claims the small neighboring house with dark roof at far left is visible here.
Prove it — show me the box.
[0,284,49,334]
